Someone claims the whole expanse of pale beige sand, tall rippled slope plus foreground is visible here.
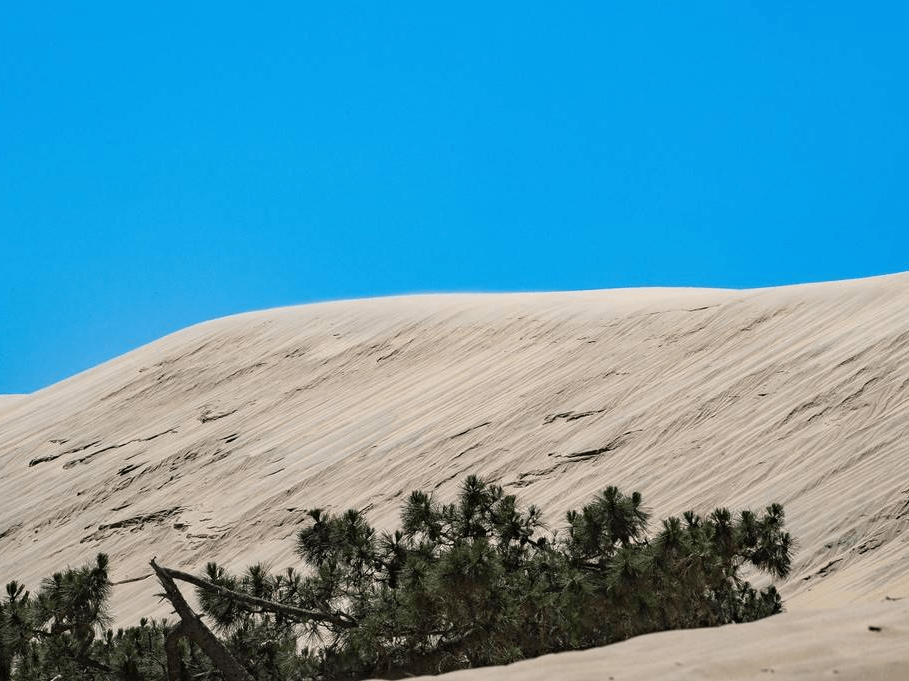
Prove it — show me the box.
[0,274,909,679]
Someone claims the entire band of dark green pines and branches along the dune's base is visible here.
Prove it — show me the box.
[0,476,792,681]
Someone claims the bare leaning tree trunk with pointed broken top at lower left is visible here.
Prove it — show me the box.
[151,558,253,681]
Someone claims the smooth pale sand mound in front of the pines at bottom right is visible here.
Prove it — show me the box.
[396,601,909,681]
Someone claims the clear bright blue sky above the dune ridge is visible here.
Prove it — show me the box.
[0,1,909,393]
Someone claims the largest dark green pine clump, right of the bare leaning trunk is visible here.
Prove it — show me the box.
[199,476,792,678]
